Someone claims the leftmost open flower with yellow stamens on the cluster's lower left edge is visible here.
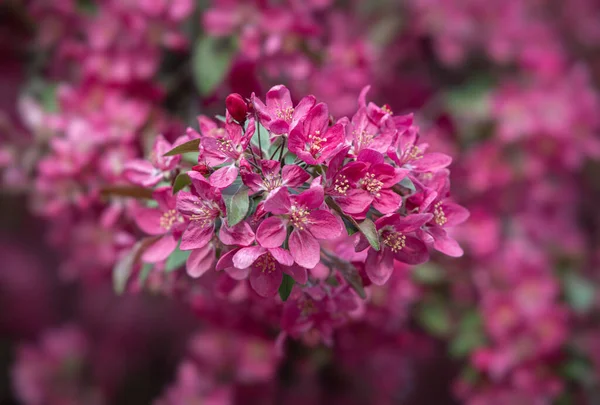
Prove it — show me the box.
[133,187,186,263]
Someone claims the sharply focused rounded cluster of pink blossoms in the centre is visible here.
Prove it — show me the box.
[125,85,469,336]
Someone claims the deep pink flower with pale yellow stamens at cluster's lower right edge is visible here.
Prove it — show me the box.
[356,214,432,285]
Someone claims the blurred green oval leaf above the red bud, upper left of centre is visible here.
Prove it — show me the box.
[192,36,234,96]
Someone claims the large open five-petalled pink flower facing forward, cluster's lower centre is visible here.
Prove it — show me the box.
[256,182,343,269]
